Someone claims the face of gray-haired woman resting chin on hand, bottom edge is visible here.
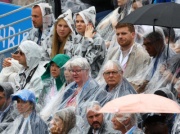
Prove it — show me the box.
[50,116,64,134]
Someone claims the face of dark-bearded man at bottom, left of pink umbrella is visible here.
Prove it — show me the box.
[87,106,103,130]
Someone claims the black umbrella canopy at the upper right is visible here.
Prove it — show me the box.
[120,2,180,28]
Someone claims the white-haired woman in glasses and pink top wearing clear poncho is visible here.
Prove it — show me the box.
[41,57,99,119]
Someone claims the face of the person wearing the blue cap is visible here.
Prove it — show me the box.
[17,98,33,114]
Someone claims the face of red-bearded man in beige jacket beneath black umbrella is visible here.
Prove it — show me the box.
[116,27,135,48]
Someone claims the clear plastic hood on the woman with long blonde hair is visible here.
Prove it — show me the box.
[56,9,75,34]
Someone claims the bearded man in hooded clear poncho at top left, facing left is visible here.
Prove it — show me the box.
[23,3,54,60]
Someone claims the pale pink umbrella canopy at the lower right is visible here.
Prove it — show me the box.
[99,94,180,113]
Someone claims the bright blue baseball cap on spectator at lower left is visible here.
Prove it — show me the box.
[12,89,36,104]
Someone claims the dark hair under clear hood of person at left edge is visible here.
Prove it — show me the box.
[0,82,14,99]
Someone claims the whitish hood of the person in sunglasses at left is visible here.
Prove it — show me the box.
[19,40,42,69]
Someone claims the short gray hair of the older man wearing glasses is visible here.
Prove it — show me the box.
[102,60,123,73]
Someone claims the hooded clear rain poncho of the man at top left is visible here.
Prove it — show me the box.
[23,3,54,60]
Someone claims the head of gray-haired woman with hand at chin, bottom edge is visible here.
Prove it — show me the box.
[50,107,77,134]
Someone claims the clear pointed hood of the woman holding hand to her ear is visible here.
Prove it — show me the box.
[74,6,96,27]
